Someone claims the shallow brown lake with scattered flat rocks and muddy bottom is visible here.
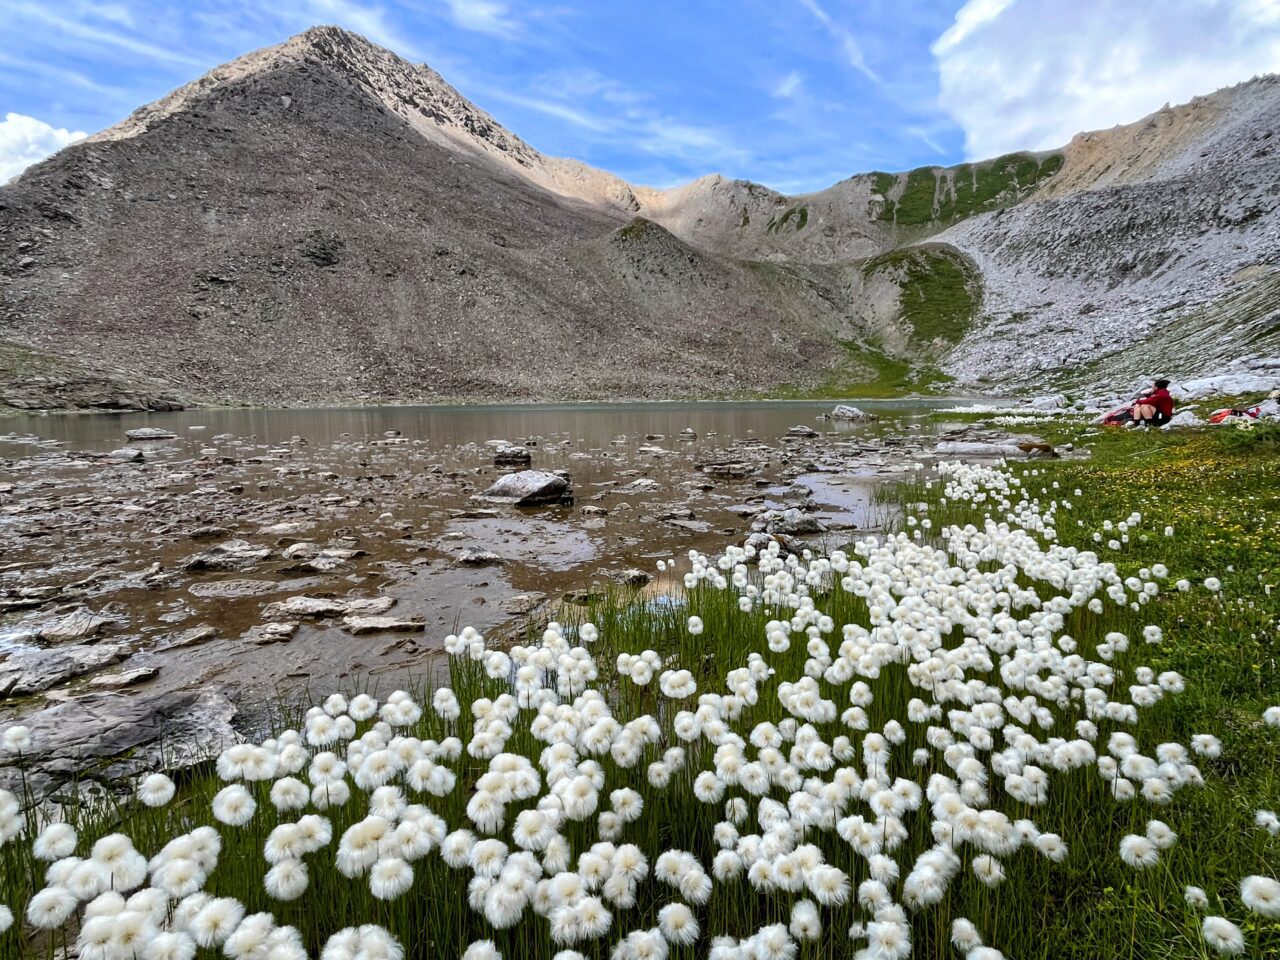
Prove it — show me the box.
[0,399,977,786]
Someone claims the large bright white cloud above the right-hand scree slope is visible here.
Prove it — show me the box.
[932,0,1280,160]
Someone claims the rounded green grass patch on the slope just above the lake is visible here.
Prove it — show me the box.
[863,244,982,348]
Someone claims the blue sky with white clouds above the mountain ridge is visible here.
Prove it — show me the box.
[0,0,1280,192]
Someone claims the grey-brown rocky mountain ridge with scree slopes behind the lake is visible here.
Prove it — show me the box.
[0,27,1280,406]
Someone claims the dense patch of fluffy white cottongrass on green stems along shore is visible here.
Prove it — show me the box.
[0,463,1280,960]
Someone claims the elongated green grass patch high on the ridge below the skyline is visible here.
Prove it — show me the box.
[872,154,1062,227]
